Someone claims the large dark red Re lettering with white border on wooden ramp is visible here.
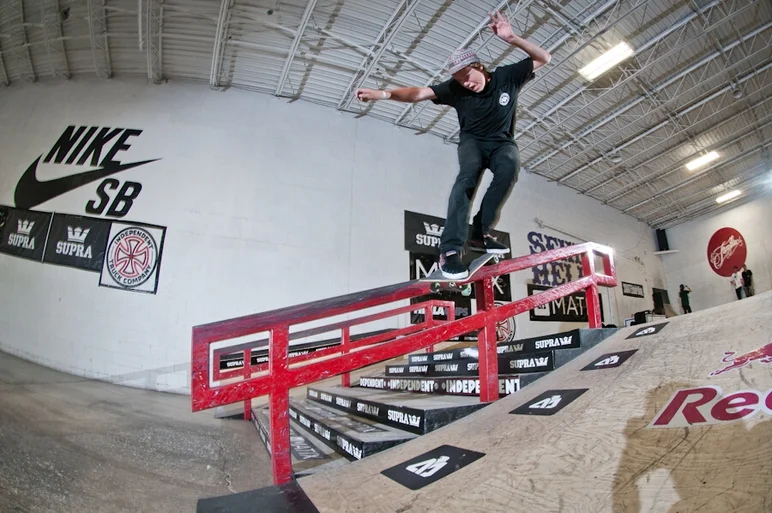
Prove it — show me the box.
[649,386,772,428]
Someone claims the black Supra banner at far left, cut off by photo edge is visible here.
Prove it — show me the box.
[0,208,51,261]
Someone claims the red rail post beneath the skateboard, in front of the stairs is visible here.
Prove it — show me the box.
[475,278,499,402]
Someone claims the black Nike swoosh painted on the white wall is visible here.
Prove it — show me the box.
[14,154,161,209]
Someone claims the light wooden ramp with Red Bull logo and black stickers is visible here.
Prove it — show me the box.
[296,293,772,513]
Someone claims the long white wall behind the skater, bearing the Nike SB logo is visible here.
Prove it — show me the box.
[0,79,664,391]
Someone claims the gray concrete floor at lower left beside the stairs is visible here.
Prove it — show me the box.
[0,353,272,513]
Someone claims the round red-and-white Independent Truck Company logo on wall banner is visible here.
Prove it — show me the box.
[107,227,158,288]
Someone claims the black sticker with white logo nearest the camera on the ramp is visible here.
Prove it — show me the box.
[381,445,485,490]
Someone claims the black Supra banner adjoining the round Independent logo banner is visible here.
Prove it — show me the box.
[43,214,110,272]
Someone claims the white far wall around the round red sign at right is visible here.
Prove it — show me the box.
[662,195,772,313]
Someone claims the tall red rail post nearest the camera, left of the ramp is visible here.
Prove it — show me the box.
[268,326,292,485]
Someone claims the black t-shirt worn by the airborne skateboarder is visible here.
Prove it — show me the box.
[430,57,535,141]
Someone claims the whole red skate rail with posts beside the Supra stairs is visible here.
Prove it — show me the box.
[191,242,617,484]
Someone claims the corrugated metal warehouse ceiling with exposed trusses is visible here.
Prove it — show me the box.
[0,0,772,228]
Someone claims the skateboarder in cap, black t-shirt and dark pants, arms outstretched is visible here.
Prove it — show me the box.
[356,11,551,279]
